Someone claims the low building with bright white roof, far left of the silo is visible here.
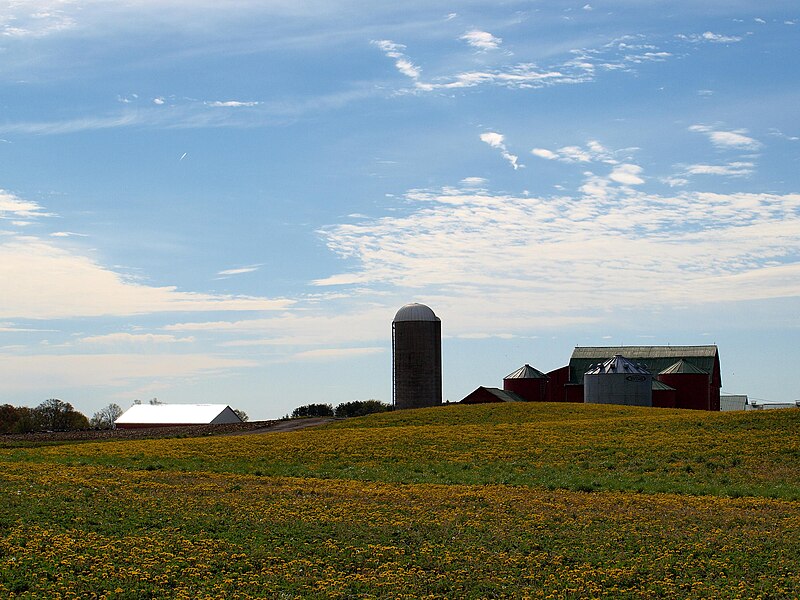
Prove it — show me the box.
[114,404,242,429]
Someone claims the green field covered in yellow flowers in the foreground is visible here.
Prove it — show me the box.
[0,404,800,599]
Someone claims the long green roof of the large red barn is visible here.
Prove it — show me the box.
[569,346,722,387]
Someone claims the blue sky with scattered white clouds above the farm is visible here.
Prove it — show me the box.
[0,0,800,419]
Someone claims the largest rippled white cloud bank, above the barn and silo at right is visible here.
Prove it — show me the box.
[316,183,800,335]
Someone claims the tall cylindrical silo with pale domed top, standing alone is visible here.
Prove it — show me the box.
[392,303,442,409]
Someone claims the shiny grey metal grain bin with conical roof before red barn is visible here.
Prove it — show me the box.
[583,354,653,406]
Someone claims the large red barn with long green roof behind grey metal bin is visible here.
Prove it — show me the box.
[545,346,722,410]
